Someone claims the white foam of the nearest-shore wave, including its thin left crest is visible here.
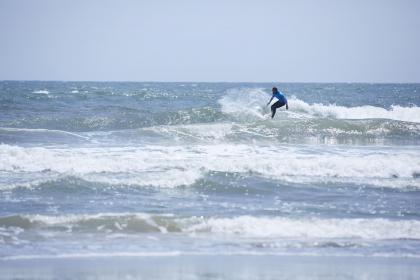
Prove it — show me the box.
[9,213,420,240]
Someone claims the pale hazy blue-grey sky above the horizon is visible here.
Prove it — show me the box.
[0,0,420,82]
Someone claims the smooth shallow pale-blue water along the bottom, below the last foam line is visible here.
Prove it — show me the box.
[0,255,420,280]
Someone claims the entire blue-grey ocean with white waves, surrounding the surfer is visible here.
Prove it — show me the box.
[0,81,420,279]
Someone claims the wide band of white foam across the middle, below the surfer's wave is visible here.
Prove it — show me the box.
[0,144,420,188]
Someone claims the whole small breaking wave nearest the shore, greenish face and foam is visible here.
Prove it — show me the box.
[0,213,420,240]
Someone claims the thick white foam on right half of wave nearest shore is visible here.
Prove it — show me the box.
[184,216,420,240]
